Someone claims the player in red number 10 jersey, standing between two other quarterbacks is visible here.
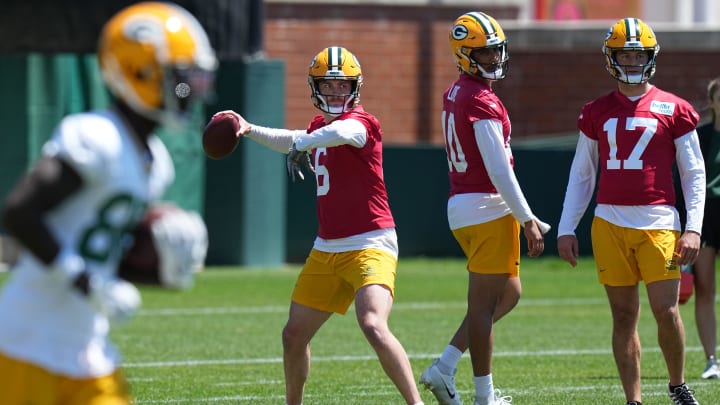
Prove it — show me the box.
[420,12,550,405]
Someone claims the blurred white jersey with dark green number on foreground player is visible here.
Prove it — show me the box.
[0,111,175,378]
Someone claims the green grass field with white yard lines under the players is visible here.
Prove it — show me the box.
[1,256,720,405]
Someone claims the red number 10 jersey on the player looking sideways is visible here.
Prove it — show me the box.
[442,74,513,196]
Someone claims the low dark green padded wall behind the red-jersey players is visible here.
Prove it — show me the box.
[286,146,594,262]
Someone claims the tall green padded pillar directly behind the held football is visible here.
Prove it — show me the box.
[205,60,287,266]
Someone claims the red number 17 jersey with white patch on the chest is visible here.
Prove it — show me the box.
[578,87,699,205]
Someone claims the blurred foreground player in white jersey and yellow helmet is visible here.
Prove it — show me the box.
[0,3,217,405]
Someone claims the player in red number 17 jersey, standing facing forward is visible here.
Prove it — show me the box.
[558,18,705,405]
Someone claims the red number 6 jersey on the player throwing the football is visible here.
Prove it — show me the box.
[308,106,395,239]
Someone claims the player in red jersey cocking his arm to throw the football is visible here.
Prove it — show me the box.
[217,46,422,405]
